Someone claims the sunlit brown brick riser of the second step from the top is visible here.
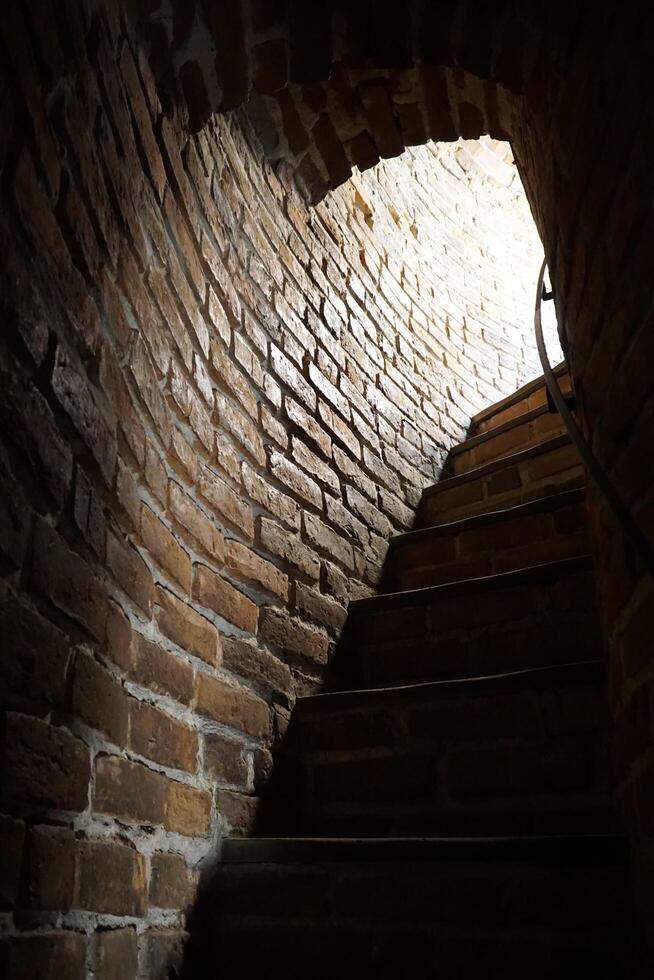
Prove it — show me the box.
[446,405,566,476]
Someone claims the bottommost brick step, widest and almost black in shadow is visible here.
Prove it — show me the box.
[204,837,634,980]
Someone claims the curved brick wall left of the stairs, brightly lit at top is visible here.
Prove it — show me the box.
[0,0,538,980]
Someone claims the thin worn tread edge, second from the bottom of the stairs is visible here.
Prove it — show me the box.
[296,660,604,718]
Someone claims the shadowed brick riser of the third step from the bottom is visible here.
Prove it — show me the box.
[333,556,602,687]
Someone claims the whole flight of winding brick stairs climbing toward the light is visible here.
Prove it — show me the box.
[191,376,636,980]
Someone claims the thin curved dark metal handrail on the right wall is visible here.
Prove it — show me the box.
[534,259,654,576]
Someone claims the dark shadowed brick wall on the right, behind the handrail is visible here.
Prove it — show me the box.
[515,3,654,943]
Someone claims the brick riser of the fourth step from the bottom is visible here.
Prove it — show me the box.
[380,488,589,592]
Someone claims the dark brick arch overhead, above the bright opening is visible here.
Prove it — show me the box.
[141,0,550,202]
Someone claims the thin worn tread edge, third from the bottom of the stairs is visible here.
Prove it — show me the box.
[349,555,593,616]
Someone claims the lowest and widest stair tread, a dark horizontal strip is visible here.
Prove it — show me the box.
[220,834,629,868]
